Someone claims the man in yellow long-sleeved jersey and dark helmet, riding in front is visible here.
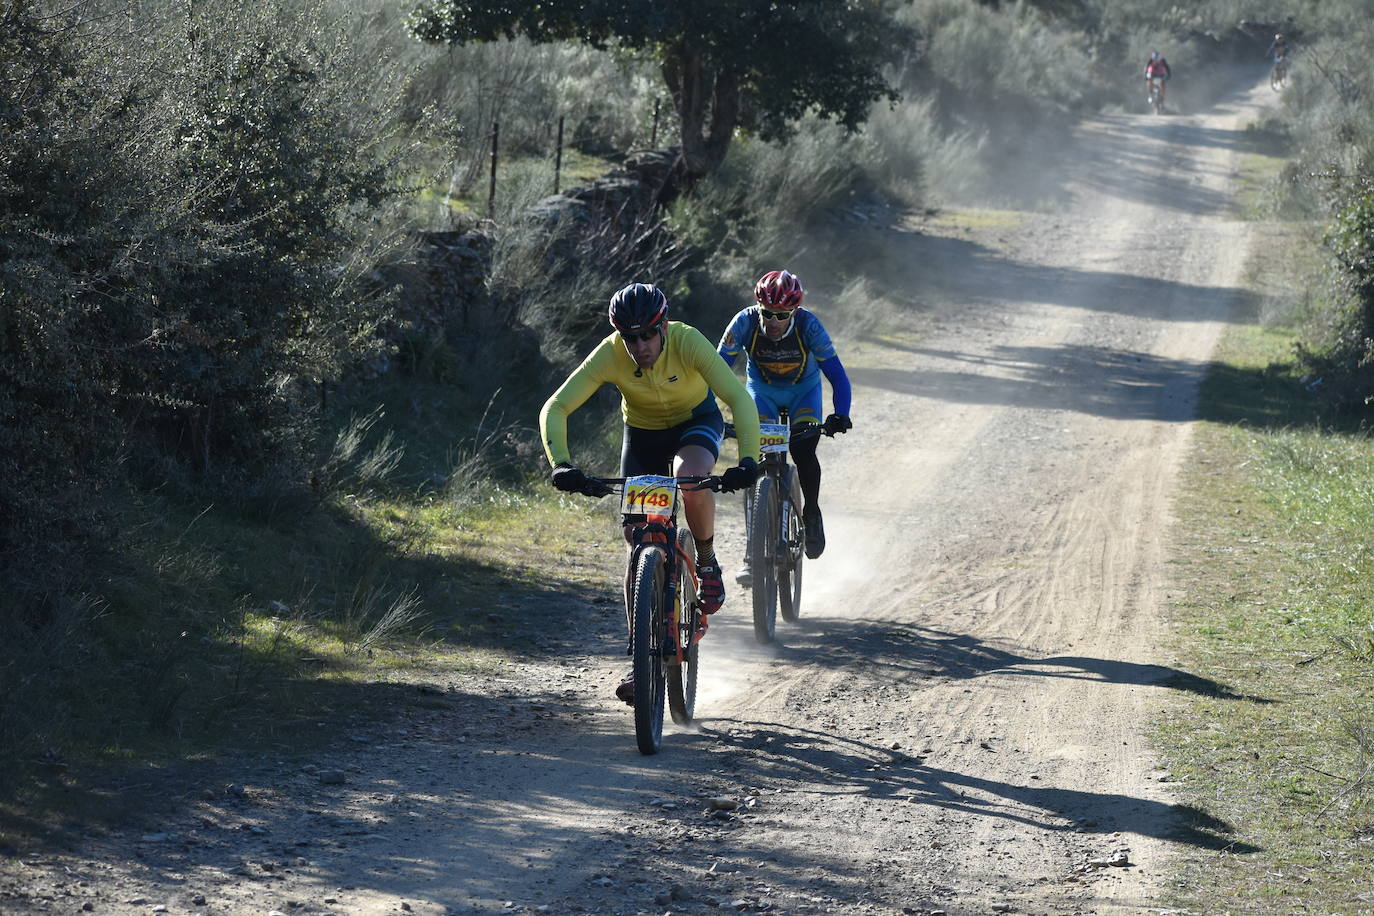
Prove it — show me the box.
[539,283,758,702]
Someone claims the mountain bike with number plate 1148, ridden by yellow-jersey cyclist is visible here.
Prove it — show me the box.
[588,475,720,754]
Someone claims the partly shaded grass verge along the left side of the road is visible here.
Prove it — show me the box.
[0,477,622,853]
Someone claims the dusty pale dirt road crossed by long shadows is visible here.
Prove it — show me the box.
[0,76,1268,915]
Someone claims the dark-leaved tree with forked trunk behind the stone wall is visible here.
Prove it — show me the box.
[409,0,914,187]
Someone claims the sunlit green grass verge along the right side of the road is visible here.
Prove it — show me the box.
[1157,218,1374,913]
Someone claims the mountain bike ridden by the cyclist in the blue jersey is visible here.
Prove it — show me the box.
[725,411,824,643]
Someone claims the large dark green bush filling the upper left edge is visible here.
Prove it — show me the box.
[0,0,436,774]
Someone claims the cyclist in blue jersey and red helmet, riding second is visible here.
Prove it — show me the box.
[716,271,853,584]
